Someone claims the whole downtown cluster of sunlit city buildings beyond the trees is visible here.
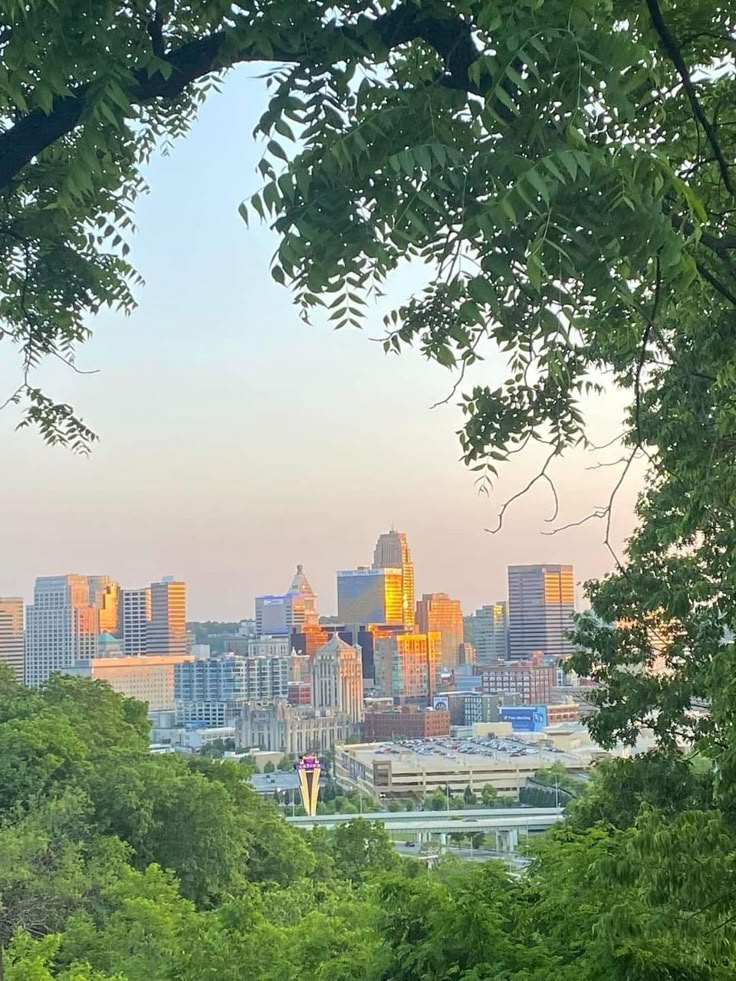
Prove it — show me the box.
[0,529,578,754]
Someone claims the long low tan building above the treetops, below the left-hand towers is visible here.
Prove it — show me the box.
[69,654,194,712]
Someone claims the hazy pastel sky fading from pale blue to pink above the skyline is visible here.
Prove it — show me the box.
[0,71,637,619]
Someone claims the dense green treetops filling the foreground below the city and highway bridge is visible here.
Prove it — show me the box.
[0,674,736,981]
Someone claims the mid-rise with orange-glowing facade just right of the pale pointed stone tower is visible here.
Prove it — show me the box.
[374,632,442,701]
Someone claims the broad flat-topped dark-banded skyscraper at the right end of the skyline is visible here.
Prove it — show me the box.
[509,565,575,659]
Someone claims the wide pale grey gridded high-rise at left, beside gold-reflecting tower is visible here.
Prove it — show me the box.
[25,575,100,686]
